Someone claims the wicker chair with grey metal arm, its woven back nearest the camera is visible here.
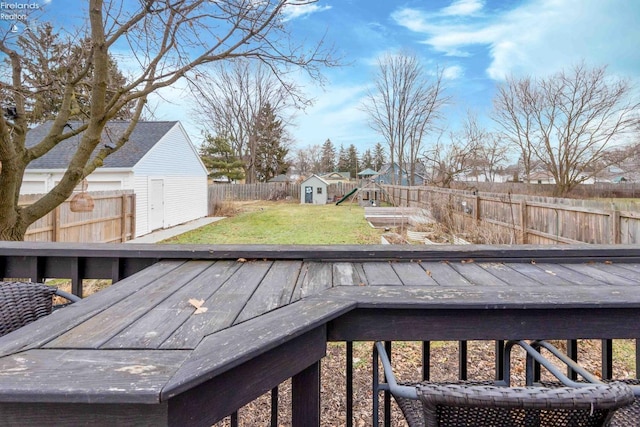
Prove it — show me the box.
[374,342,634,427]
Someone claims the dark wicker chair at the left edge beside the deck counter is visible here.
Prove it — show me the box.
[0,282,80,336]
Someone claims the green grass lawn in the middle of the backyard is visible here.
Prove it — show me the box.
[163,202,382,245]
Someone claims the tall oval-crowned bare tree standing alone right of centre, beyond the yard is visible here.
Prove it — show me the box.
[362,53,449,185]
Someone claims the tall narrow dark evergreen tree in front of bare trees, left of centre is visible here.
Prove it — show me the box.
[254,103,289,182]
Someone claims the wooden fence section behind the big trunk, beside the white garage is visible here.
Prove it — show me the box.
[20,190,135,243]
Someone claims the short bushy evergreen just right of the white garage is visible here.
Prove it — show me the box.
[200,134,244,182]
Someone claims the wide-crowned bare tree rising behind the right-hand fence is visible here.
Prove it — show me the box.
[496,63,640,195]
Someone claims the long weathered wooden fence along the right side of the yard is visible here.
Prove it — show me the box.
[383,185,640,244]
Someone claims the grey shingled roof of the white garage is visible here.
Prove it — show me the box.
[26,121,178,169]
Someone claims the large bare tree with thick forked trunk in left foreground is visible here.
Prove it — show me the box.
[0,0,334,240]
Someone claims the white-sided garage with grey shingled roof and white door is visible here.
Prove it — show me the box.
[20,121,207,237]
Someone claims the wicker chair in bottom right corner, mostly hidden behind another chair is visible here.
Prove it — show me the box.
[525,340,640,427]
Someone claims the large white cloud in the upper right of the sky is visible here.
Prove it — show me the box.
[392,0,640,80]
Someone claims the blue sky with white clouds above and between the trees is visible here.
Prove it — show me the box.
[6,0,640,152]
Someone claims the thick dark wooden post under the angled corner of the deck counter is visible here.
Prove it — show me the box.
[291,361,320,427]
